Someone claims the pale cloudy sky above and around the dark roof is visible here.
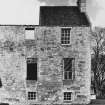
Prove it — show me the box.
[0,0,105,27]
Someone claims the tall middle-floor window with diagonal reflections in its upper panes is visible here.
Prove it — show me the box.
[63,58,74,80]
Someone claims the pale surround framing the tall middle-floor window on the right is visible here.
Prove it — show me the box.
[63,57,75,80]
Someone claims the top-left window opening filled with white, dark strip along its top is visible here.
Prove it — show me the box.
[25,28,35,40]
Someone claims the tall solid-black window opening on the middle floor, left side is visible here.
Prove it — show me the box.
[27,58,37,80]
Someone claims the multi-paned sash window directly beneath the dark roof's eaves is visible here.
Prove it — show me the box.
[61,28,71,44]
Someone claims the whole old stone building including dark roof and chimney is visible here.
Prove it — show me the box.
[0,0,91,105]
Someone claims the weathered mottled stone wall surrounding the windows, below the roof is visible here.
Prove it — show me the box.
[0,26,91,105]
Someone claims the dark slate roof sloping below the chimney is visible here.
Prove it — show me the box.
[39,6,90,26]
